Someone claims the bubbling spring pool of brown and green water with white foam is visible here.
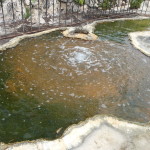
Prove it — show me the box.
[0,20,150,143]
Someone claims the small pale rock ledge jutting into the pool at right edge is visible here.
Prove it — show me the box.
[129,31,150,56]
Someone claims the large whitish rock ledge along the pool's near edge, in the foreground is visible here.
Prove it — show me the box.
[0,116,150,150]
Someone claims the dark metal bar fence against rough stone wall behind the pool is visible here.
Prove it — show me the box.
[0,0,150,39]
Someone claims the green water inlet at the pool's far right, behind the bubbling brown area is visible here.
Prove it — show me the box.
[95,19,150,43]
